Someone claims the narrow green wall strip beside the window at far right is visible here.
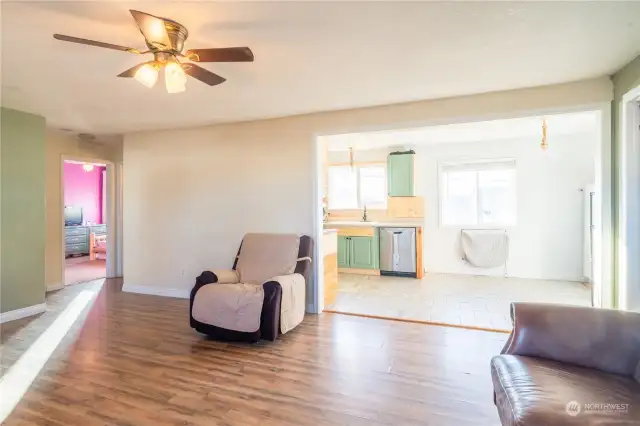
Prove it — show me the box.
[611,56,640,310]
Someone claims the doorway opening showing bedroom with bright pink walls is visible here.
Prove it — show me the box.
[62,160,109,286]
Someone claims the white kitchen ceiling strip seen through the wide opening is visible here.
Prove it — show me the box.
[323,111,600,151]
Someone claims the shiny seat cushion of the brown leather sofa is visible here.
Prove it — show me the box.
[491,355,640,426]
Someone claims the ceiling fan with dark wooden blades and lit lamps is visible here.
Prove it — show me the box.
[53,10,253,93]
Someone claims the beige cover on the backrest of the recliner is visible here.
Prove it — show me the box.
[236,234,300,284]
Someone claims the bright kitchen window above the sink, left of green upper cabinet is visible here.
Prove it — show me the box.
[327,164,387,210]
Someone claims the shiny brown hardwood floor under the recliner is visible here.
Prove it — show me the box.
[3,280,507,426]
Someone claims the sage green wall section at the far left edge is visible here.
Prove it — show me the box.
[0,108,46,312]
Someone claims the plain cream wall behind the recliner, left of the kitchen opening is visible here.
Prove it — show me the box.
[124,126,313,294]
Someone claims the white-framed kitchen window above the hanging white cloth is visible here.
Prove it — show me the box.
[440,160,517,227]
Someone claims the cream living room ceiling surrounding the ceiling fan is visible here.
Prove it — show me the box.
[2,1,640,133]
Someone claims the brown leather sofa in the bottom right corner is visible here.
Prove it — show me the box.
[491,303,640,426]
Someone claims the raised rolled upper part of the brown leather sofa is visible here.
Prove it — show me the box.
[502,303,640,378]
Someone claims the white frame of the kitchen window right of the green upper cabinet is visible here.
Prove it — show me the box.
[438,158,518,230]
